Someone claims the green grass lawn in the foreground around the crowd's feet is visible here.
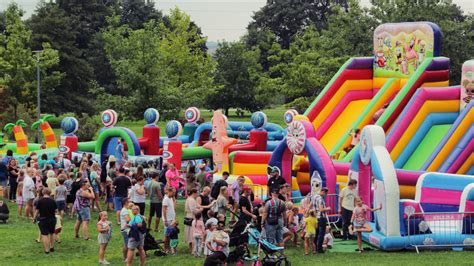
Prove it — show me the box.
[0,201,474,266]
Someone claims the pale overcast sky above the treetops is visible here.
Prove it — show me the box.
[0,0,474,41]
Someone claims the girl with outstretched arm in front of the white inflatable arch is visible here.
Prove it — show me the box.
[349,197,382,253]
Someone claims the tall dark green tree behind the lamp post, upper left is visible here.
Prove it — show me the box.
[28,3,93,114]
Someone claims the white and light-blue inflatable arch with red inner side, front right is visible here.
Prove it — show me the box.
[349,125,400,236]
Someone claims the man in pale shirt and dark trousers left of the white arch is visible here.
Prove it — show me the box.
[338,179,357,240]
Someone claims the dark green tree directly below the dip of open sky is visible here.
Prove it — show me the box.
[207,42,262,115]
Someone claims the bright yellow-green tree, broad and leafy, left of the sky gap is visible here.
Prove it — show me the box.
[103,9,214,117]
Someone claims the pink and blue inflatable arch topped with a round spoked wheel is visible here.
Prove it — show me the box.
[268,121,336,194]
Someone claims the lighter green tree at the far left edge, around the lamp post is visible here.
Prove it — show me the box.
[0,4,61,119]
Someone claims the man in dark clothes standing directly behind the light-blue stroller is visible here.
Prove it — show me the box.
[262,188,286,247]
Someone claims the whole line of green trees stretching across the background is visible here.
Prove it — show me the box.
[0,0,474,119]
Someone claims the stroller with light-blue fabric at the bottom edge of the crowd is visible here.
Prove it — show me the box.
[245,224,291,266]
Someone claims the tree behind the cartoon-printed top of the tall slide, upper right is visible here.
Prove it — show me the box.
[370,1,474,84]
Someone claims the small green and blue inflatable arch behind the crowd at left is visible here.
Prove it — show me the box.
[95,127,140,161]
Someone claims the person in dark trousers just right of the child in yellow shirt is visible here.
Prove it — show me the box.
[313,187,331,253]
